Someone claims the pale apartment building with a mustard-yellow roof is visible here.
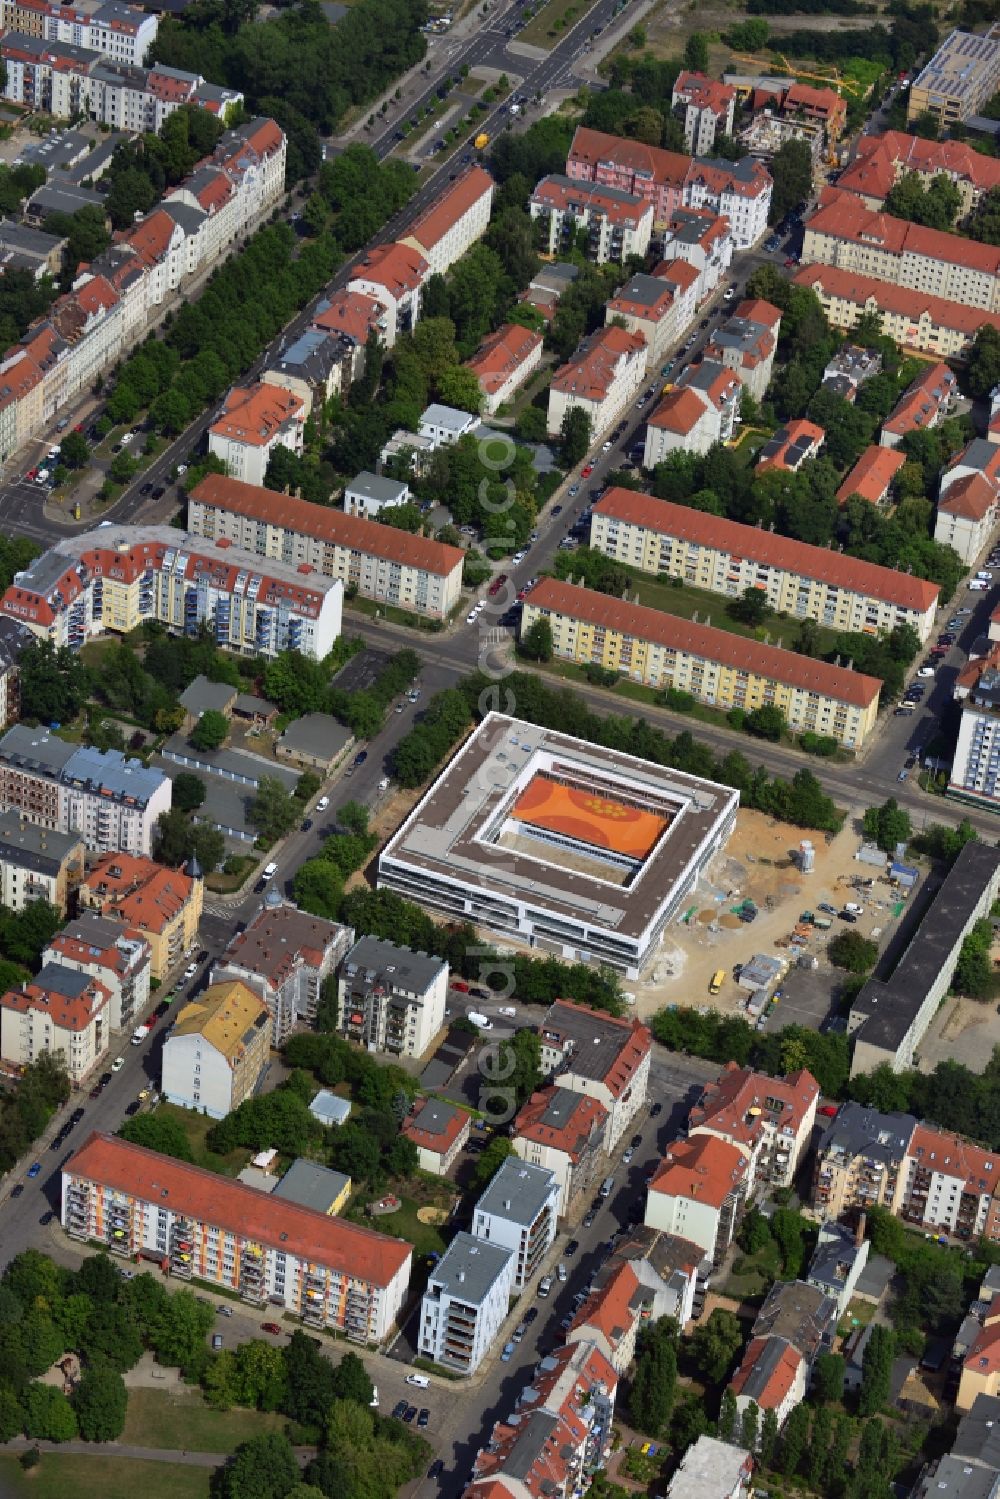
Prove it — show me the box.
[160,979,271,1120]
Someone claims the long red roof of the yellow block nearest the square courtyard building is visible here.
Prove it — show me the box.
[529,577,882,708]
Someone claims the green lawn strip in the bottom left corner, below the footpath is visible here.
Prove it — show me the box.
[0,1453,211,1499]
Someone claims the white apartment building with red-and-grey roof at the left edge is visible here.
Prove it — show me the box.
[0,962,111,1085]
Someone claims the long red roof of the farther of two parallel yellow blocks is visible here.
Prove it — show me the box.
[593,487,940,615]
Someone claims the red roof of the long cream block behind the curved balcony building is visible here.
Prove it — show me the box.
[192,474,465,577]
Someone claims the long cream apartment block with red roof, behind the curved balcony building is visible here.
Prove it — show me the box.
[187,474,465,619]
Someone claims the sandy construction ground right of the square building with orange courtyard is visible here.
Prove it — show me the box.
[630,811,917,1019]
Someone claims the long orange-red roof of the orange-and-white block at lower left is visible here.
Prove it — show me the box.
[63,1133,411,1286]
